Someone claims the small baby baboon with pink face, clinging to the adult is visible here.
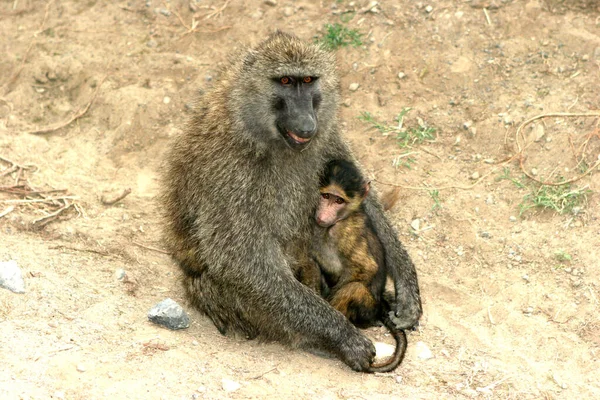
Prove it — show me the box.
[312,160,407,372]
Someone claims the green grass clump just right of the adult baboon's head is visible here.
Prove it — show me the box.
[358,107,436,147]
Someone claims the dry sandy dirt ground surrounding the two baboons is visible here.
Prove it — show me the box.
[0,0,600,399]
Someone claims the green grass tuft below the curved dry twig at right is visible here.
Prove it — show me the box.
[519,184,591,215]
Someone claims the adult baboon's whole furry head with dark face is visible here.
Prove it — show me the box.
[228,32,339,151]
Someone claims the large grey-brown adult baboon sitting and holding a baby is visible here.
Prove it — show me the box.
[162,32,422,371]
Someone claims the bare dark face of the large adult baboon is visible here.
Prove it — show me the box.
[273,76,321,150]
